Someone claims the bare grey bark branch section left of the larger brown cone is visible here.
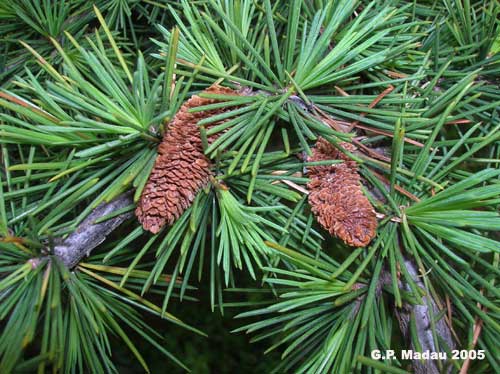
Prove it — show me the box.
[53,193,133,269]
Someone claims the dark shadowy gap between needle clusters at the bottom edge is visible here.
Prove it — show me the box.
[113,279,281,374]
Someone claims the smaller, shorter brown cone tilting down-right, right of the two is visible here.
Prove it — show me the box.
[307,138,377,247]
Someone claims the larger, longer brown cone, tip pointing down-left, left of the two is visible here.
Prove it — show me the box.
[135,85,238,234]
